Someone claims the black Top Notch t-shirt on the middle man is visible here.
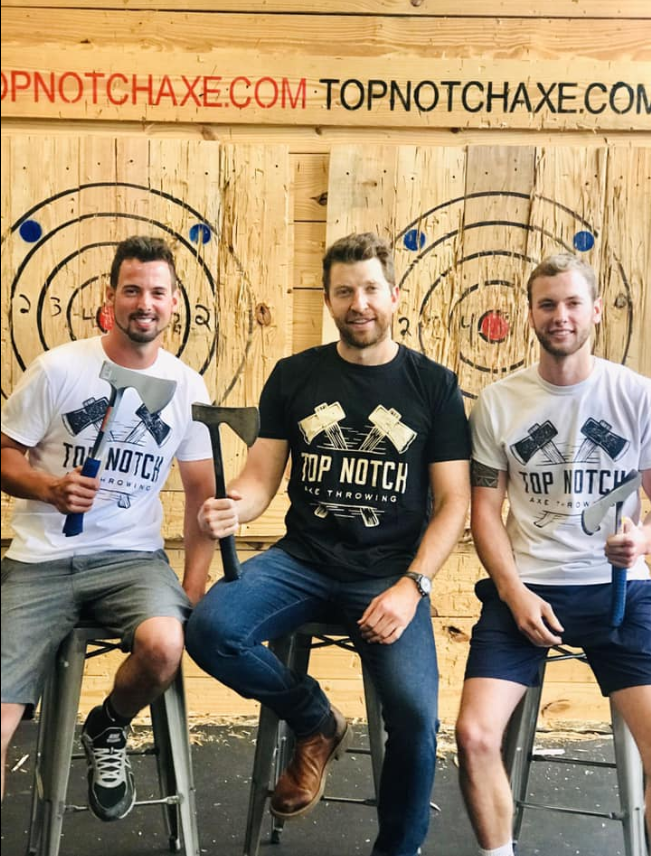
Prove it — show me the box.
[260,344,470,580]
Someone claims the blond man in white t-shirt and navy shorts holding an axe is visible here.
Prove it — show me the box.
[457,253,651,856]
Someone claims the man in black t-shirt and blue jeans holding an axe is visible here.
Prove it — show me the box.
[187,234,470,856]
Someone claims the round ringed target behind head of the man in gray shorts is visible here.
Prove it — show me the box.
[2,182,255,401]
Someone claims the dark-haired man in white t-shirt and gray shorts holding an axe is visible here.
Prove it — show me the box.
[1,237,214,820]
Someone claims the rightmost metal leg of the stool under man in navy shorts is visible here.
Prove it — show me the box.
[610,702,648,856]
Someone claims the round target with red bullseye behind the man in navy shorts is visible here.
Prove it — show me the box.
[394,191,633,398]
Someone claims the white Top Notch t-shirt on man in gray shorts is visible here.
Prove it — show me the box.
[2,337,212,563]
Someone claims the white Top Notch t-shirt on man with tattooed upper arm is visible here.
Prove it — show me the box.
[470,358,651,585]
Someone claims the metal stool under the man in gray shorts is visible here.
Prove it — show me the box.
[27,622,199,856]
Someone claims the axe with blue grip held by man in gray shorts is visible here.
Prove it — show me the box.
[63,360,176,537]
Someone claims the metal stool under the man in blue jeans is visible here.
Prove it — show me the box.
[243,623,385,856]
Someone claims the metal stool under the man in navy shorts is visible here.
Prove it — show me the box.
[504,646,647,856]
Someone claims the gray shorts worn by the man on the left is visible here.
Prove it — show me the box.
[2,550,191,705]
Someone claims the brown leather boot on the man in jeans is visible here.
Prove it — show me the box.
[271,707,352,820]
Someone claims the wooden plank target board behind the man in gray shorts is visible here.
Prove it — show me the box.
[2,136,292,538]
